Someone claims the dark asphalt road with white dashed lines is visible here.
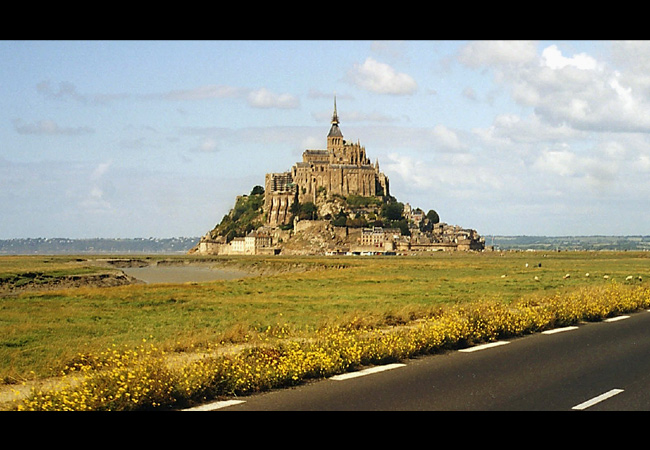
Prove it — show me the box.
[184,311,650,411]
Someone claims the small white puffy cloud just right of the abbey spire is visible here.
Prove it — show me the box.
[347,57,417,95]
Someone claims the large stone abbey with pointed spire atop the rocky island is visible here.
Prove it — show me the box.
[264,99,390,226]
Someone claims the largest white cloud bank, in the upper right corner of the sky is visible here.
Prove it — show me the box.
[458,41,650,133]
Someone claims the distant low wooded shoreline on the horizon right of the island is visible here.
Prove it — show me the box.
[485,235,650,251]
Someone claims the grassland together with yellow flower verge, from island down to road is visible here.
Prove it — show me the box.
[0,252,650,410]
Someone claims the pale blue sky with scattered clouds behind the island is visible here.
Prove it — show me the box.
[0,40,650,239]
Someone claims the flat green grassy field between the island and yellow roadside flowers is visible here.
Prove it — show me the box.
[0,252,650,383]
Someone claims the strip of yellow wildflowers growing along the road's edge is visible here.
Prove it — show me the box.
[15,283,650,410]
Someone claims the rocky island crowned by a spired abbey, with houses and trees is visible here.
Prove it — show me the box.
[190,98,485,255]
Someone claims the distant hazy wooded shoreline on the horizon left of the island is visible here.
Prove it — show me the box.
[0,237,200,255]
